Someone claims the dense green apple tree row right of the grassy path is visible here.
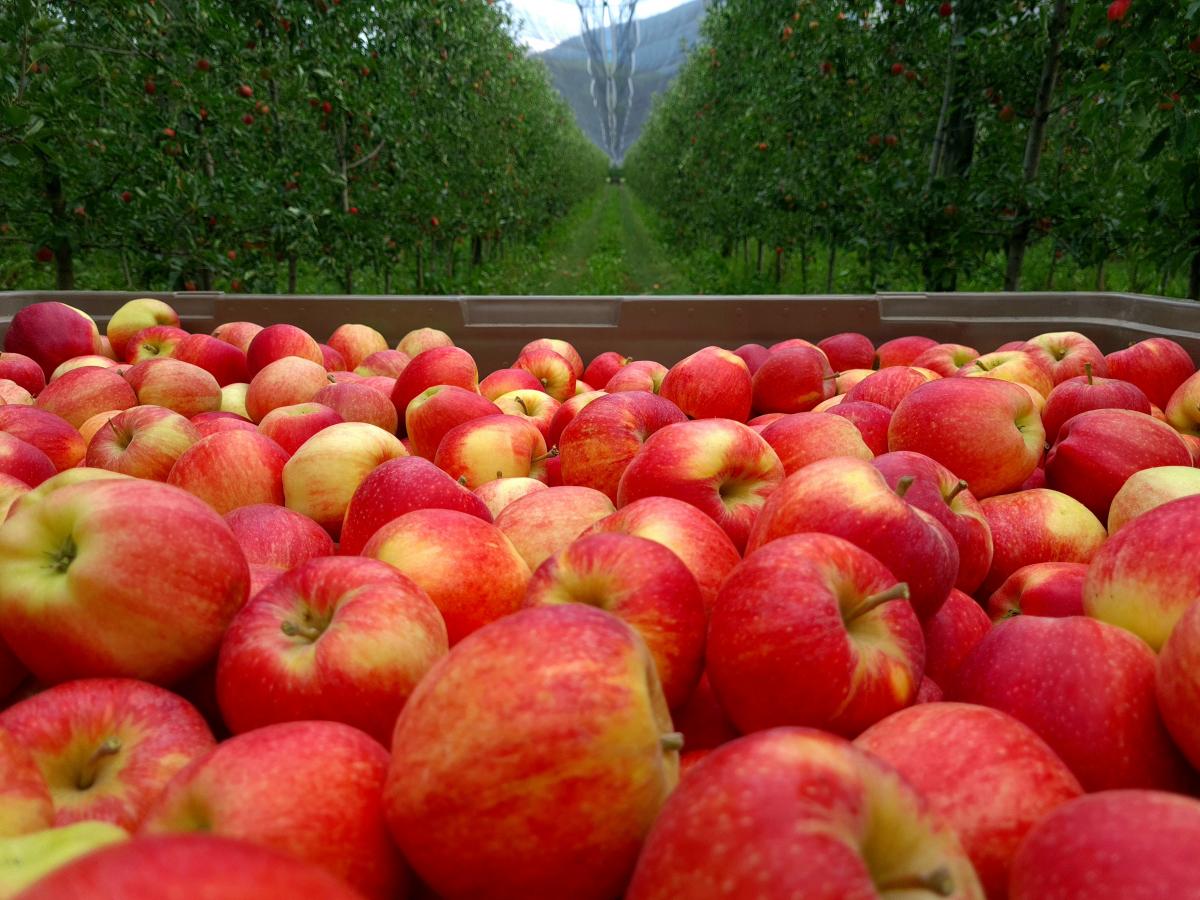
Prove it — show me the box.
[625,0,1200,298]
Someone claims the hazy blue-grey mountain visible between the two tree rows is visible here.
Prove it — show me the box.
[534,0,708,163]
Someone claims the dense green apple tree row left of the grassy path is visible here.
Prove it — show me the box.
[0,0,607,290]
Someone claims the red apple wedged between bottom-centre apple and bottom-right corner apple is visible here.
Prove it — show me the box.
[854,703,1084,900]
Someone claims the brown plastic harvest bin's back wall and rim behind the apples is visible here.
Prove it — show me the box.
[0,290,1200,373]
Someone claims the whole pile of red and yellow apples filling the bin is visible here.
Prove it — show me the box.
[0,299,1200,900]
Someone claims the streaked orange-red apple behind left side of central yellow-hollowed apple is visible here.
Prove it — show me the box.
[558,391,688,502]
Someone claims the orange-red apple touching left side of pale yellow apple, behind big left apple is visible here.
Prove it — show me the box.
[167,431,289,516]
